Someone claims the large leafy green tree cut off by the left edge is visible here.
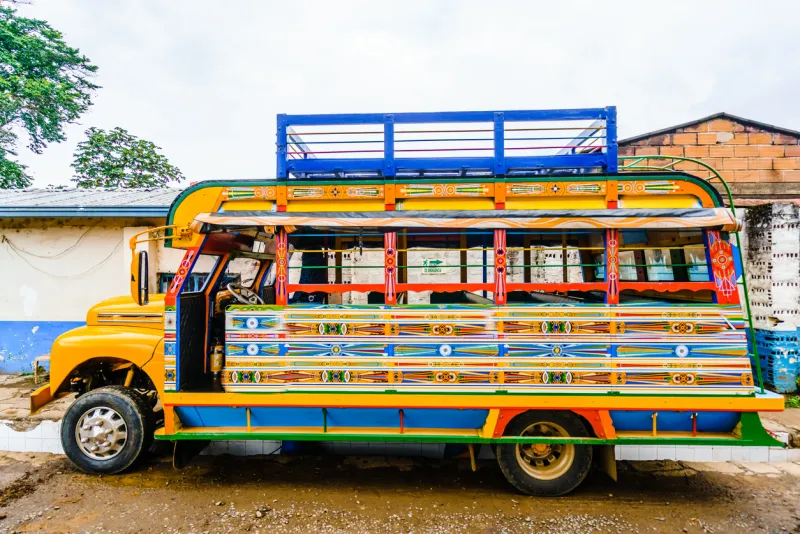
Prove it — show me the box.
[0,7,98,188]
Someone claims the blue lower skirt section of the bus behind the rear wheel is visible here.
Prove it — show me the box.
[610,410,741,432]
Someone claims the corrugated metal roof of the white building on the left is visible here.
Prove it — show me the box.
[0,187,183,218]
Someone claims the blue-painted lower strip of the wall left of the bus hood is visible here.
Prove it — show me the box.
[0,321,85,373]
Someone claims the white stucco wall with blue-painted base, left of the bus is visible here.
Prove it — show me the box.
[0,218,219,372]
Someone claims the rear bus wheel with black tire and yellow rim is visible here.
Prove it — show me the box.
[495,410,592,497]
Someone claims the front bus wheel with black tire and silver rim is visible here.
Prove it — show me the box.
[61,386,154,474]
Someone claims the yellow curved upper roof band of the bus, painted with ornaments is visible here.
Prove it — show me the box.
[167,172,735,248]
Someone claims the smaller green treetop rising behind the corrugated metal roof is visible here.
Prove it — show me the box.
[72,127,184,187]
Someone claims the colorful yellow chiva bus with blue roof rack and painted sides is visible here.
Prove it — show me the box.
[32,108,782,495]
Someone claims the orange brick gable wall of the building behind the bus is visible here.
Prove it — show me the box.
[620,119,800,199]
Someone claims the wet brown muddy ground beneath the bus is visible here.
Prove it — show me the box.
[0,453,800,533]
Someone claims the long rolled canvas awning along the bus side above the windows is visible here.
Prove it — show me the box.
[192,208,741,233]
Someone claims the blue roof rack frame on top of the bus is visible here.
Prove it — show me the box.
[277,106,617,180]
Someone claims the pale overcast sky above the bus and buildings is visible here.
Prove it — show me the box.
[10,0,800,187]
